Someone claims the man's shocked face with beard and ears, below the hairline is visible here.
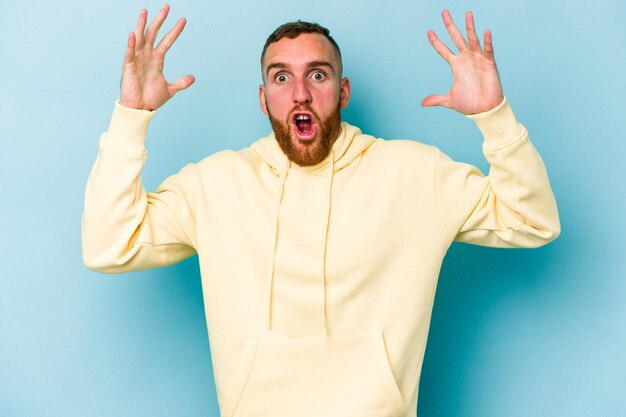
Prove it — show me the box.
[259,33,350,166]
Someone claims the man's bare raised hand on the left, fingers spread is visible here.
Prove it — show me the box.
[120,5,195,110]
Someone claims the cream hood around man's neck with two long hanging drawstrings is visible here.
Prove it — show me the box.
[250,122,375,337]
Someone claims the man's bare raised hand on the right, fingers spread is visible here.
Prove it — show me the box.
[422,10,504,114]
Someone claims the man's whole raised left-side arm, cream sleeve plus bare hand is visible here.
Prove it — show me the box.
[82,6,195,272]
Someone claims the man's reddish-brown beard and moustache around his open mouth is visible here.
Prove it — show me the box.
[268,103,341,167]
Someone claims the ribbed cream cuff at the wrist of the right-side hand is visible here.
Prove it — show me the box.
[467,98,526,150]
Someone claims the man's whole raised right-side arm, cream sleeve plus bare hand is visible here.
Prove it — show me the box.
[422,10,560,247]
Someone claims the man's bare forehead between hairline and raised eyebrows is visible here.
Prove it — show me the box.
[263,33,339,72]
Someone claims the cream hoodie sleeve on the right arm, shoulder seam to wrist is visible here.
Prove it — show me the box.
[436,99,560,248]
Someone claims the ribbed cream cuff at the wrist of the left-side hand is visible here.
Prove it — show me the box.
[100,100,156,154]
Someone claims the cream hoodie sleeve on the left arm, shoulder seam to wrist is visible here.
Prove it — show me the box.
[82,103,195,273]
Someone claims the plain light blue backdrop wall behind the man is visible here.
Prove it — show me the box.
[0,0,626,417]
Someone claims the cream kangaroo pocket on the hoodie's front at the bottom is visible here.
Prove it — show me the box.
[221,332,404,417]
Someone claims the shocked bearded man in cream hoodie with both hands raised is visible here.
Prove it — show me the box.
[83,6,559,417]
